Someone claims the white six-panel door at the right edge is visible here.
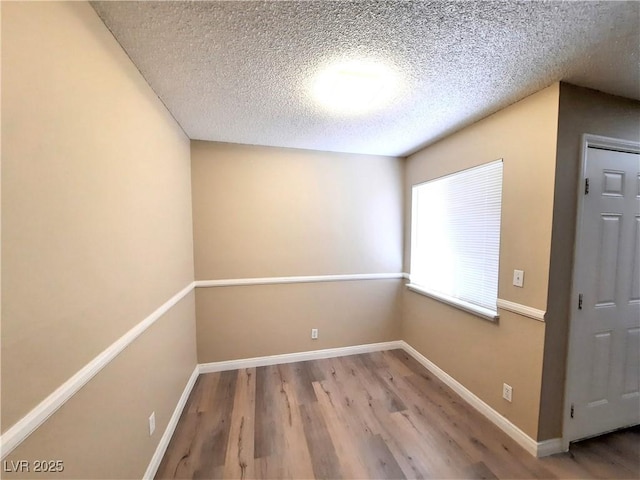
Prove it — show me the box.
[565,139,640,441]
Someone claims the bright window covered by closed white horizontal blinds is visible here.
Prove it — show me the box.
[408,160,502,320]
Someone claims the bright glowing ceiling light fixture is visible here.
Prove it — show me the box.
[312,60,398,114]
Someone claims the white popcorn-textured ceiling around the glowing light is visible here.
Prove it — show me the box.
[92,1,640,155]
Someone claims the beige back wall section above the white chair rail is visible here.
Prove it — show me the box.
[191,141,402,280]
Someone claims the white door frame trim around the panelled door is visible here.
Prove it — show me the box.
[562,133,640,451]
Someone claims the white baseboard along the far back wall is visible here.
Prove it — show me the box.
[199,340,403,373]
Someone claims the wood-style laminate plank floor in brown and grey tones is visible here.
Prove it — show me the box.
[156,350,640,479]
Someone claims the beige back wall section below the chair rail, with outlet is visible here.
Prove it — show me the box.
[196,280,403,363]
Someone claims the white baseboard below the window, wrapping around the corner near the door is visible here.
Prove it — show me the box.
[400,340,563,457]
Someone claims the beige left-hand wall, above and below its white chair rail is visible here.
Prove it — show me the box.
[2,2,195,478]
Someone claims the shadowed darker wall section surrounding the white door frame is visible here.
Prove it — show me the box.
[538,83,640,440]
